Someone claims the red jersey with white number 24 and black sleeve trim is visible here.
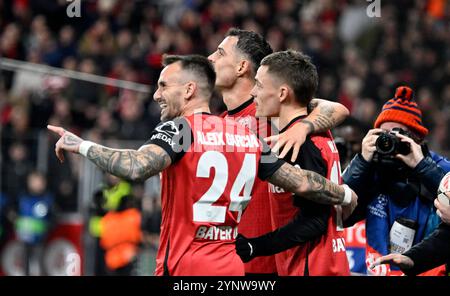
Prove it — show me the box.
[148,114,281,275]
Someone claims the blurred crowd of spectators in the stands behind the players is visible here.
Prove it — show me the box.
[0,0,450,269]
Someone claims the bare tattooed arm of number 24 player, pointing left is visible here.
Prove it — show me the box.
[48,125,172,181]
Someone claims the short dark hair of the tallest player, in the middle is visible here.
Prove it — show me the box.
[226,28,273,74]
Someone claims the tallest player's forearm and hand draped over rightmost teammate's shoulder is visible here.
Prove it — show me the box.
[265,99,350,161]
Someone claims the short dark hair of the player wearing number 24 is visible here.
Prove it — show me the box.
[162,54,216,95]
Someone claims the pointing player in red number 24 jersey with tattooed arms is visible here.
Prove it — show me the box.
[48,55,357,275]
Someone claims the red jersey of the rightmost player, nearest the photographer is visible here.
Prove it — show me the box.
[270,116,350,276]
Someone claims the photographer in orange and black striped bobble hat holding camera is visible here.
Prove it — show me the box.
[343,86,450,275]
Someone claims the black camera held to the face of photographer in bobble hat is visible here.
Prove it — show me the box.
[375,127,412,159]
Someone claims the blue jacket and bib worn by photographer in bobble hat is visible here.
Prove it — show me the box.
[343,152,450,270]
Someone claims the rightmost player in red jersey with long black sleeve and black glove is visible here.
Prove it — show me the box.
[236,51,351,276]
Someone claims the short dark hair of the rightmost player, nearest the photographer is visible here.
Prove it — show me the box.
[261,50,319,106]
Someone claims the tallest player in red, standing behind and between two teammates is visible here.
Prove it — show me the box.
[208,29,349,274]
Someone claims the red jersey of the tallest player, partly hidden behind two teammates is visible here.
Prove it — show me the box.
[222,99,277,273]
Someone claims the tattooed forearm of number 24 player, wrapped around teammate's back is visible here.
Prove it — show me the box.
[267,163,358,206]
